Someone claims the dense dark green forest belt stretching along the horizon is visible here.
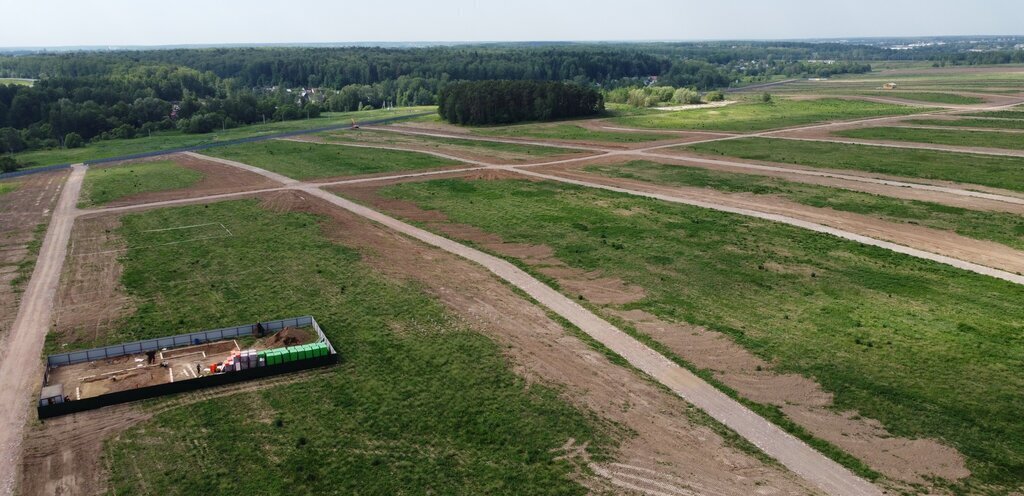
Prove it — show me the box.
[0,42,1024,161]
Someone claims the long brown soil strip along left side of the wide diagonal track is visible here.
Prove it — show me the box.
[264,190,815,495]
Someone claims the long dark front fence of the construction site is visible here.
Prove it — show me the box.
[36,353,339,419]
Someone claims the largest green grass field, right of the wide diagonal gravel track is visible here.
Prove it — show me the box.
[382,179,1024,487]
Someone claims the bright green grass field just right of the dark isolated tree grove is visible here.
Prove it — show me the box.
[613,98,922,131]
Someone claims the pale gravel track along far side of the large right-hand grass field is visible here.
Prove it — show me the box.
[502,167,1024,284]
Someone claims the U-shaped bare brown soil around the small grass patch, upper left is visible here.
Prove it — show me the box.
[91,154,281,207]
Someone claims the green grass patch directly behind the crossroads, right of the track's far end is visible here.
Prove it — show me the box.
[204,140,460,179]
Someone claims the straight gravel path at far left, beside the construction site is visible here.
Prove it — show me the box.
[0,165,85,494]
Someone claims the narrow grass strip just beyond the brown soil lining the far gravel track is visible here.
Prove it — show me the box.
[584,161,1024,250]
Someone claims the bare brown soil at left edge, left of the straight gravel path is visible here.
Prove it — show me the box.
[0,171,68,336]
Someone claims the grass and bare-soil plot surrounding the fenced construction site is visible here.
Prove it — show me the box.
[25,192,808,495]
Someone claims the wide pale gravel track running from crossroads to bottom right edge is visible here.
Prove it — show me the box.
[298,185,882,495]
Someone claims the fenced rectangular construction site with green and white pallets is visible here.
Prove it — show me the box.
[38,317,338,419]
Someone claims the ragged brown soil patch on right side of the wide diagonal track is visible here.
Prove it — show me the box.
[609,309,970,484]
